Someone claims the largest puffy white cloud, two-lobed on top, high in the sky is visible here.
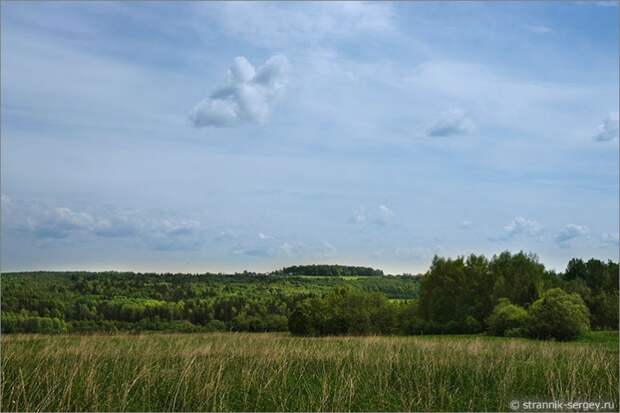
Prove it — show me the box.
[189,55,290,128]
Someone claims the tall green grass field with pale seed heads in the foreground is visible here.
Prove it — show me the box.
[2,332,618,411]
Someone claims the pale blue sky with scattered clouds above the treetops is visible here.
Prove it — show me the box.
[0,1,619,273]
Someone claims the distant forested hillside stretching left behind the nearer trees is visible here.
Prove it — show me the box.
[2,272,419,333]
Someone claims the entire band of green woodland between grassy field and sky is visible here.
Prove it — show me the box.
[2,252,618,339]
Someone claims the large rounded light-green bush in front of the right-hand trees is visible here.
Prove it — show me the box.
[528,288,590,340]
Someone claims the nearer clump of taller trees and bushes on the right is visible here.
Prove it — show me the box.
[289,252,618,340]
